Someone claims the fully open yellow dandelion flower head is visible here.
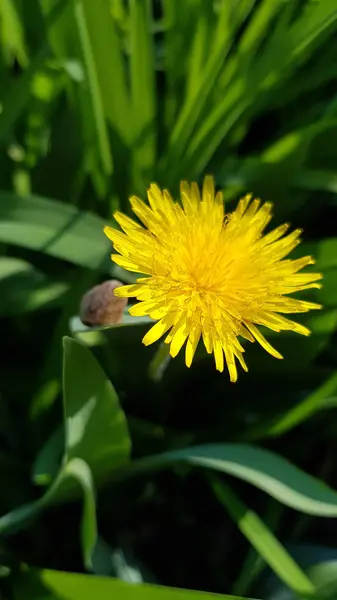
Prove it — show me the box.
[104,176,322,381]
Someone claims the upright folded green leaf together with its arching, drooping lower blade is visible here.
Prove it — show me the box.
[0,338,130,565]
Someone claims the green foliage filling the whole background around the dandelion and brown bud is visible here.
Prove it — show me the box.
[0,0,337,600]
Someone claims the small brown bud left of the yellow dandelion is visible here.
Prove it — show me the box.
[80,279,128,327]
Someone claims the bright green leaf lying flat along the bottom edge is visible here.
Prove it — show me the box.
[40,571,249,600]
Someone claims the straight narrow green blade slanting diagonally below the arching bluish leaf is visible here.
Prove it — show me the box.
[209,475,315,595]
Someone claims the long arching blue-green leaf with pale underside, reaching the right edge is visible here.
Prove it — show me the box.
[124,444,337,517]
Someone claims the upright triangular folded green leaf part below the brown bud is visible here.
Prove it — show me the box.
[63,337,131,481]
